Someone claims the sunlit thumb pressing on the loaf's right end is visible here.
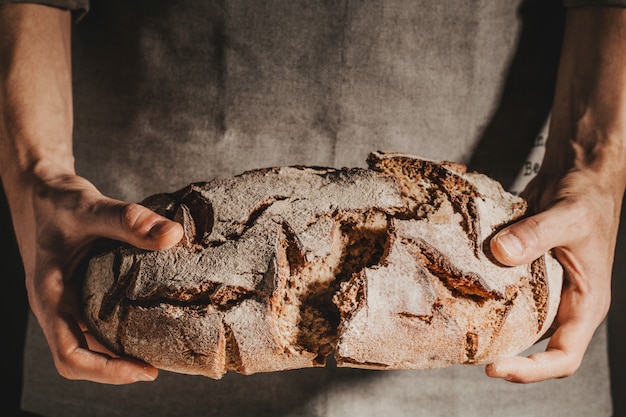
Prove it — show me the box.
[489,206,571,266]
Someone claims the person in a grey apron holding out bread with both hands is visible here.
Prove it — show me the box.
[0,0,626,415]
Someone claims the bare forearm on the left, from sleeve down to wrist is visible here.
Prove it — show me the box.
[0,4,74,201]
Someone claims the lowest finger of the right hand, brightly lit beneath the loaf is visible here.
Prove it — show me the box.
[485,314,596,384]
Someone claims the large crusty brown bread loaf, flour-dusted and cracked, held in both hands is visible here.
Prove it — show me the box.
[83,152,562,378]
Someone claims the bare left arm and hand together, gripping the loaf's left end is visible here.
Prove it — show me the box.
[0,3,183,384]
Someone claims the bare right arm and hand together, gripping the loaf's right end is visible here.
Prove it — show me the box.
[486,7,626,382]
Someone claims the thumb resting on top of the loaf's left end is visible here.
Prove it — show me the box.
[83,199,183,250]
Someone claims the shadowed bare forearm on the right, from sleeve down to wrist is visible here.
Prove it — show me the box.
[543,7,626,195]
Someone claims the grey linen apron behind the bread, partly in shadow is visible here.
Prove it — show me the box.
[23,0,611,417]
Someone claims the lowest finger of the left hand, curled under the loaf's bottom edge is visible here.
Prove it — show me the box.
[47,308,158,385]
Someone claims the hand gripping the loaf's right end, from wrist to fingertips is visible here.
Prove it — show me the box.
[486,161,623,383]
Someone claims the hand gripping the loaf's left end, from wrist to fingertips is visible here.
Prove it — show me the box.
[10,174,183,384]
